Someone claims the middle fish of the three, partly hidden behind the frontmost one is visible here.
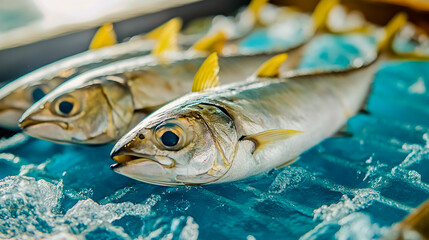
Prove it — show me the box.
[20,0,342,144]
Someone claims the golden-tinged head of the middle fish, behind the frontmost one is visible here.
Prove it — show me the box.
[20,76,134,144]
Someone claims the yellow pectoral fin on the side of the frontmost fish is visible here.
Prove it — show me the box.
[243,129,303,153]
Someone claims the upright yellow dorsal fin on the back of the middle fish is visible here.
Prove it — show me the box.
[152,19,180,56]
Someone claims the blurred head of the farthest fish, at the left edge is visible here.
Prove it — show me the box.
[0,76,66,130]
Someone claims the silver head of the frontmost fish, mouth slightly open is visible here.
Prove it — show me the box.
[111,103,237,186]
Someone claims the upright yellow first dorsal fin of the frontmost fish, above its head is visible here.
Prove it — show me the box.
[192,52,219,92]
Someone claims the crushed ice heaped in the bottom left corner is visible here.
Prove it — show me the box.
[0,176,198,240]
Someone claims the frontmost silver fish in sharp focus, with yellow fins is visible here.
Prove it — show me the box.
[111,14,406,186]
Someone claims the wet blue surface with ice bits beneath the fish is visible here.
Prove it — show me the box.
[0,36,429,239]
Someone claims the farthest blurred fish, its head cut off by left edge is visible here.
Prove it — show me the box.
[0,18,181,130]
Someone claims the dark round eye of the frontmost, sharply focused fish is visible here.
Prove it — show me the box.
[155,123,186,151]
